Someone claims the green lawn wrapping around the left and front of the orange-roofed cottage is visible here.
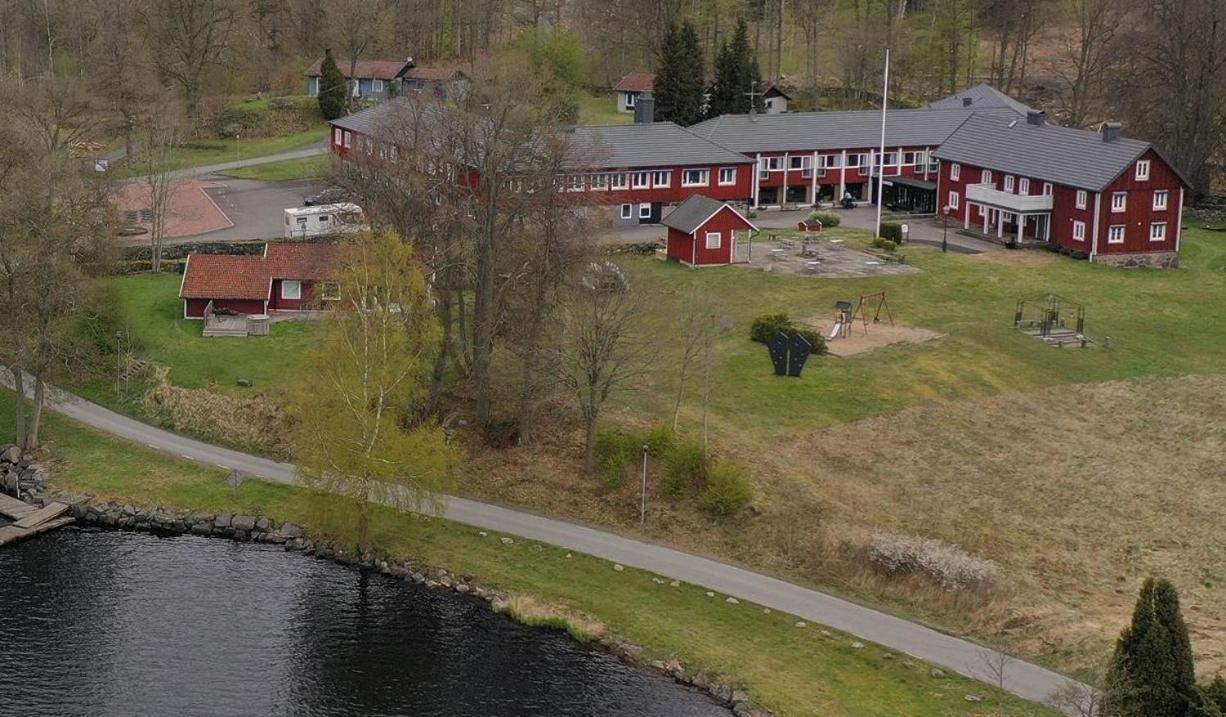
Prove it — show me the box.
[107,273,319,393]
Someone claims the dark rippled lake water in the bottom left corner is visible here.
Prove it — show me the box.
[0,529,728,717]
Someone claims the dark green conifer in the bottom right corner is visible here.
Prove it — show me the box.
[1103,579,1199,717]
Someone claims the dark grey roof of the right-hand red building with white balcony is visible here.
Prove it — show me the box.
[937,116,1176,191]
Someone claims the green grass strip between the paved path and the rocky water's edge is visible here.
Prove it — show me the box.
[0,392,1049,717]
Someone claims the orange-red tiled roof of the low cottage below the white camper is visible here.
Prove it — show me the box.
[179,241,338,300]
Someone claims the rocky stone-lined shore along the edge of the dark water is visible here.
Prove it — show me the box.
[0,446,771,717]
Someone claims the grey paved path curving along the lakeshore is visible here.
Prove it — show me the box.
[21,379,1072,702]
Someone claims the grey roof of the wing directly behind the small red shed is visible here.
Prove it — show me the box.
[574,123,750,169]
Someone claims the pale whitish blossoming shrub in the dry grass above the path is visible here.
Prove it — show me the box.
[868,532,1000,591]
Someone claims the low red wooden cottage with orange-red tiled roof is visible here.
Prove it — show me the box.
[179,241,340,319]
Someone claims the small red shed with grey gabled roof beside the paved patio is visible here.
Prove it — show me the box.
[663,195,758,266]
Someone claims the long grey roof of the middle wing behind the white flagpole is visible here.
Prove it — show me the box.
[690,109,1019,153]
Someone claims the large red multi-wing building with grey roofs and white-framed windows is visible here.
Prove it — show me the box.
[331,85,1188,264]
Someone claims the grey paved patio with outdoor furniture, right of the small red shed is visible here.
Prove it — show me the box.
[737,238,920,278]
